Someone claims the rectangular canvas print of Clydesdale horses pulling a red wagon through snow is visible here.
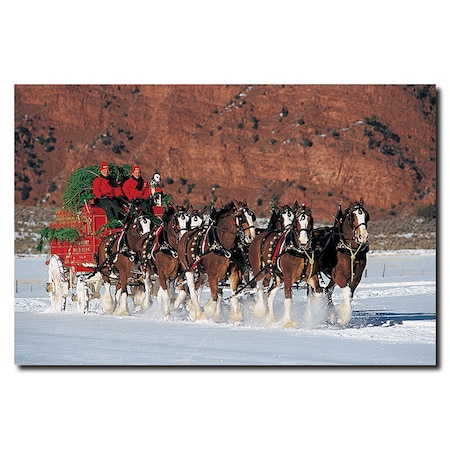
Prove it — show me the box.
[14,84,438,367]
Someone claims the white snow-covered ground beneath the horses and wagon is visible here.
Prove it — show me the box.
[14,251,437,367]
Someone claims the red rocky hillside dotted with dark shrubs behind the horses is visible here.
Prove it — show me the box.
[15,85,437,219]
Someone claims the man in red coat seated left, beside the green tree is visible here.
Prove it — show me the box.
[92,161,123,221]
